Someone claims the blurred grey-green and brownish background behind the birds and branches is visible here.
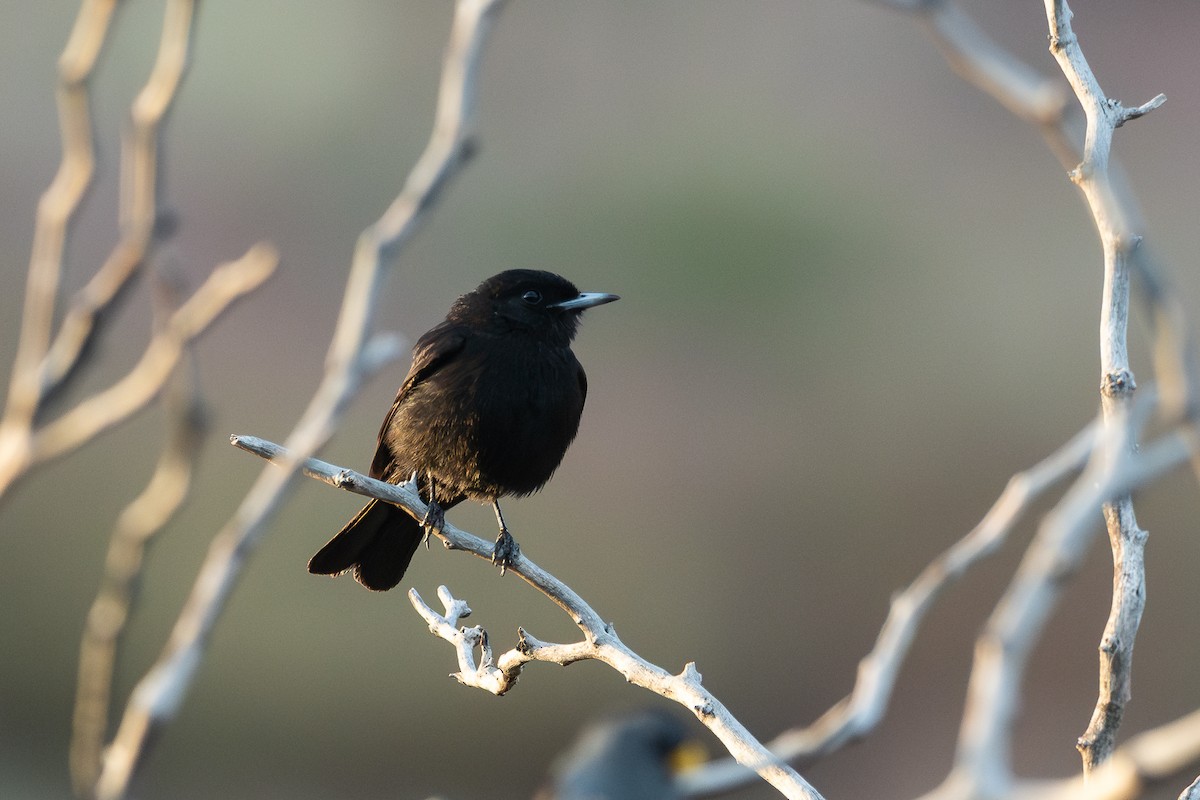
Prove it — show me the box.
[0,0,1200,800]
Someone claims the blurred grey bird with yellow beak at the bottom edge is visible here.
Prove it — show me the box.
[534,710,701,800]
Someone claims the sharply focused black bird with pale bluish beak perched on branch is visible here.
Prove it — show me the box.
[308,270,618,591]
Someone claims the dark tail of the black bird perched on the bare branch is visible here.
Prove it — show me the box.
[308,500,425,591]
